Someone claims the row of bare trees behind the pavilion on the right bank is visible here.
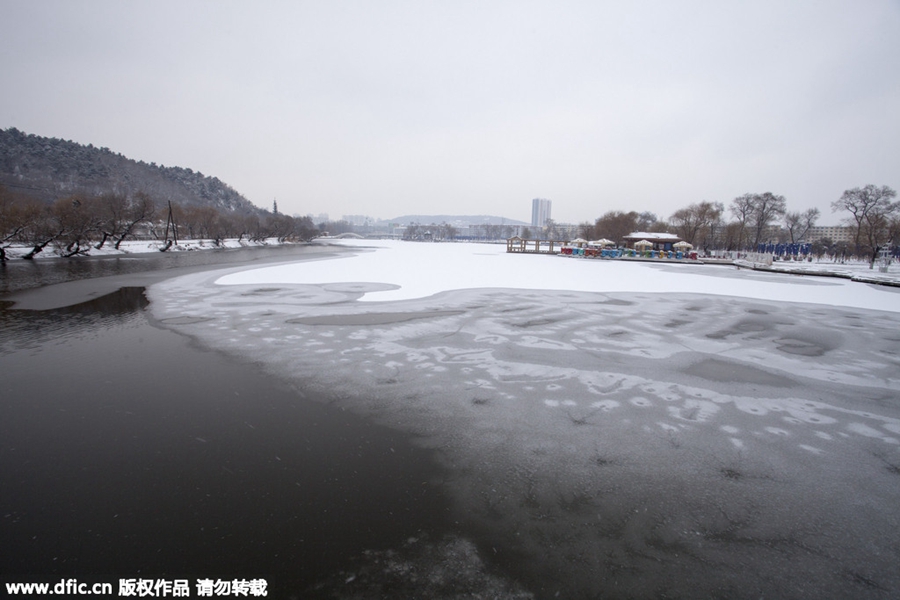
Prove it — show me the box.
[568,185,900,261]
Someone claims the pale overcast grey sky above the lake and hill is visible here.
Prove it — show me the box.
[0,0,900,225]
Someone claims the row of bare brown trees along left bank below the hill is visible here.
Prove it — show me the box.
[0,186,318,260]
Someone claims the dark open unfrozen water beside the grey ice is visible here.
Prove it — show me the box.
[0,247,449,598]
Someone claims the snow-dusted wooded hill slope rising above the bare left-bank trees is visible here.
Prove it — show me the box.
[0,127,262,214]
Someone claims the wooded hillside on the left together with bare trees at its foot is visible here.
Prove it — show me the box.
[0,128,317,261]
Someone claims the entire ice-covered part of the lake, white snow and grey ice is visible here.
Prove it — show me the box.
[150,241,900,598]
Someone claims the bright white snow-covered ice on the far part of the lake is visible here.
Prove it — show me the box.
[216,240,900,311]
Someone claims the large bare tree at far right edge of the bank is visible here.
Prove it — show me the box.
[831,184,900,268]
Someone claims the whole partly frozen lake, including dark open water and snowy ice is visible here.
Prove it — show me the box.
[0,242,900,598]
